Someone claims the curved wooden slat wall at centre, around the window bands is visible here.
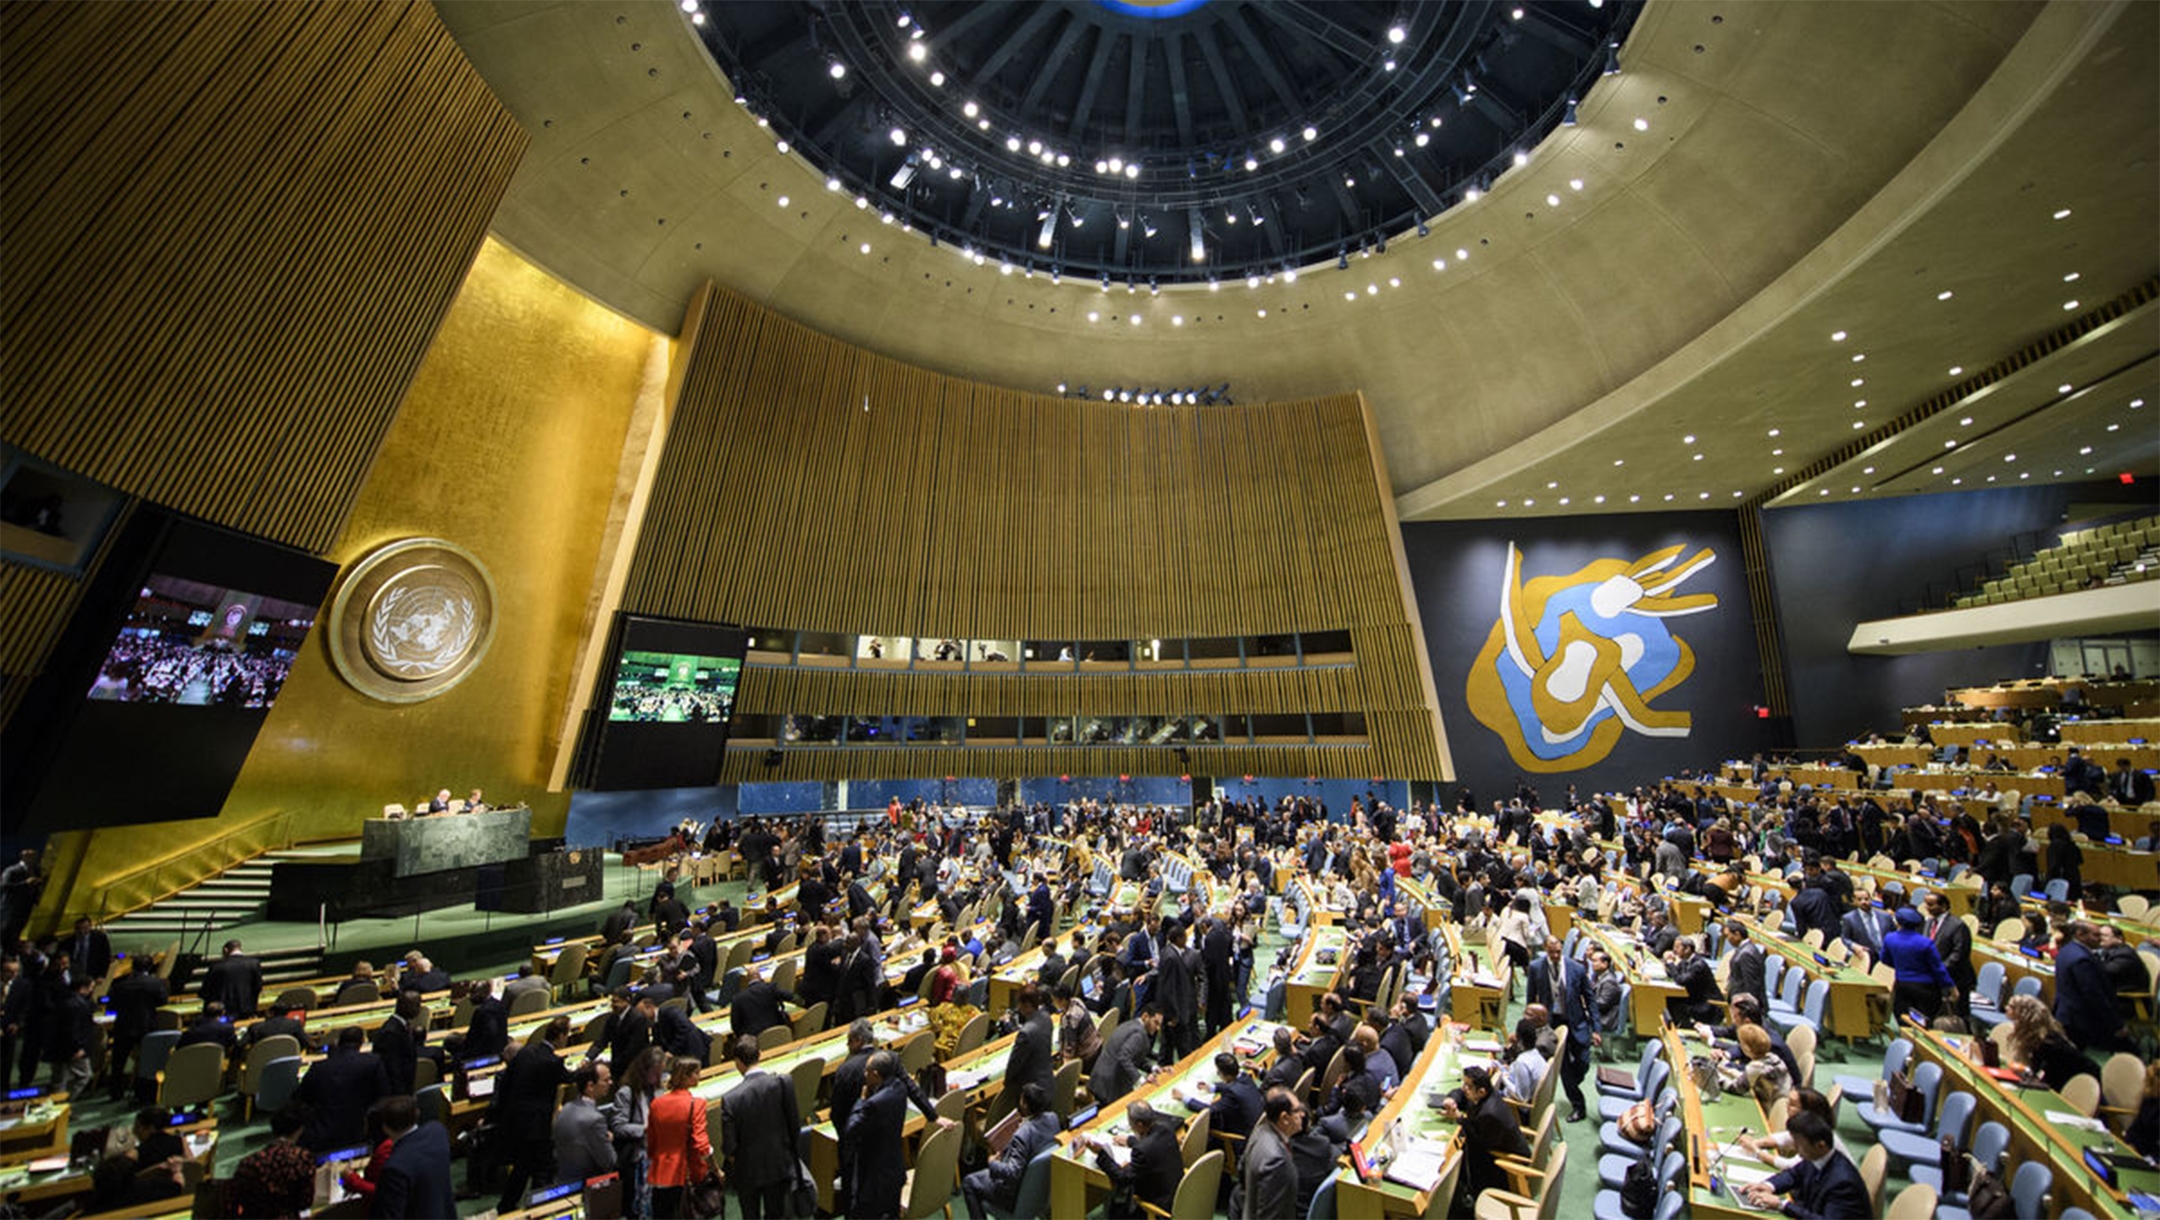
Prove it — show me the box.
[622,285,1445,780]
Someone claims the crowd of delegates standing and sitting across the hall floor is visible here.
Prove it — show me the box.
[0,760,2160,1218]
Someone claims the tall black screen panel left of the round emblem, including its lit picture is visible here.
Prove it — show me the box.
[0,505,337,831]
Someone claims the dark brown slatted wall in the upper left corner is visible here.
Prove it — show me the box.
[0,0,525,552]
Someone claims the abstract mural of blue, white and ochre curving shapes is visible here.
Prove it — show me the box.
[1467,542,1717,773]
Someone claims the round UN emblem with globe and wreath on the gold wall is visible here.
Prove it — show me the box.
[330,538,495,704]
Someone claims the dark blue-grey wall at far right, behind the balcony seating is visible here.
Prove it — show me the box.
[1763,475,2154,747]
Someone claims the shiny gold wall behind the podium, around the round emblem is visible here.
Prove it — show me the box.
[54,242,667,919]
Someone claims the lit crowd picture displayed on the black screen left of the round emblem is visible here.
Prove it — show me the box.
[91,574,315,708]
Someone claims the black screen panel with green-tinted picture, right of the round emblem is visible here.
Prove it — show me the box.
[577,615,750,790]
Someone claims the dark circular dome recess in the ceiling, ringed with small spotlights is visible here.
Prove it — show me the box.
[693,0,1639,285]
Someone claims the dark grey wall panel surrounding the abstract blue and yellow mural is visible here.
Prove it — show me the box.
[1402,512,1776,801]
